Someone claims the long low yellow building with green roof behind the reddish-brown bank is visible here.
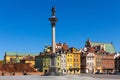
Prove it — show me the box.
[4,52,37,67]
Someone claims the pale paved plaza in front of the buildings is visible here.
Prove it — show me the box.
[0,75,120,80]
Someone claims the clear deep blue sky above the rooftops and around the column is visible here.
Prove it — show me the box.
[0,0,120,59]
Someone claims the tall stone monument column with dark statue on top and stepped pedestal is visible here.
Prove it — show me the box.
[49,7,58,75]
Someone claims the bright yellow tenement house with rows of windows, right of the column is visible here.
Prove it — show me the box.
[66,48,81,74]
